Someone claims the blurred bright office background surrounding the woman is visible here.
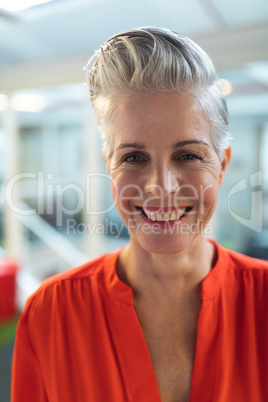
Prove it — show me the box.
[0,0,268,402]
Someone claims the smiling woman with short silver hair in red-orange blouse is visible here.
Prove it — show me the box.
[12,27,268,402]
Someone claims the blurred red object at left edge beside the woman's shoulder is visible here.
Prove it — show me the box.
[0,258,18,320]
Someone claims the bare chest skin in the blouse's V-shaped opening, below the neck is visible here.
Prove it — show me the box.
[136,300,198,402]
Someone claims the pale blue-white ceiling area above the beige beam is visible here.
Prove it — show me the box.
[0,0,268,67]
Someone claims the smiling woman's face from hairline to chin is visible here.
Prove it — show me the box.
[108,93,228,254]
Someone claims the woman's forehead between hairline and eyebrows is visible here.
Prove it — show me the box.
[110,93,211,143]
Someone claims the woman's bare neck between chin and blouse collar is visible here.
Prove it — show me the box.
[117,236,214,297]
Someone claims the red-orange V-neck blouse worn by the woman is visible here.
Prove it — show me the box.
[12,240,268,402]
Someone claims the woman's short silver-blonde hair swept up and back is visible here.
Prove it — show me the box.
[85,27,230,159]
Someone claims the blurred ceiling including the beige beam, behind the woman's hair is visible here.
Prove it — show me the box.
[0,0,268,113]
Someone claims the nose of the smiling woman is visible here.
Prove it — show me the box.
[145,166,179,198]
